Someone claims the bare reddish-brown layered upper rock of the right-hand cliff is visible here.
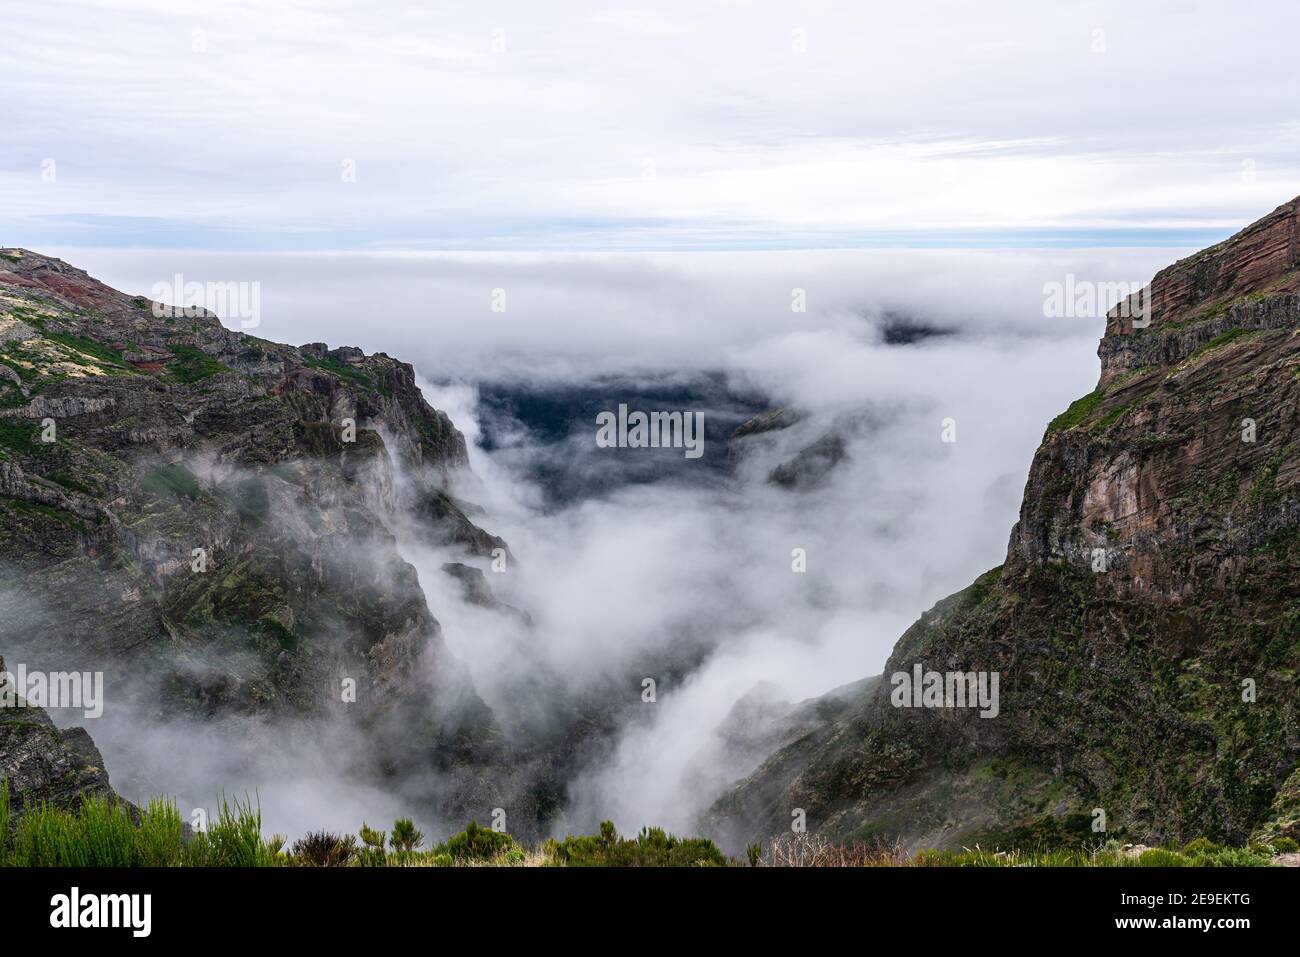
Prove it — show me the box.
[1008,195,1300,602]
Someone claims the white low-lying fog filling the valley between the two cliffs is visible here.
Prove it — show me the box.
[40,250,1182,833]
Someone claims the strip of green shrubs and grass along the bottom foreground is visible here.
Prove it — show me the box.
[0,779,1274,867]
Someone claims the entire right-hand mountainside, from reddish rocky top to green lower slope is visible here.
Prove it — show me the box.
[711,200,1300,846]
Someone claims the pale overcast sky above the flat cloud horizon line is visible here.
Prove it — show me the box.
[0,0,1300,250]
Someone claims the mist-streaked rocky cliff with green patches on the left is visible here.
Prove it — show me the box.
[0,250,504,821]
